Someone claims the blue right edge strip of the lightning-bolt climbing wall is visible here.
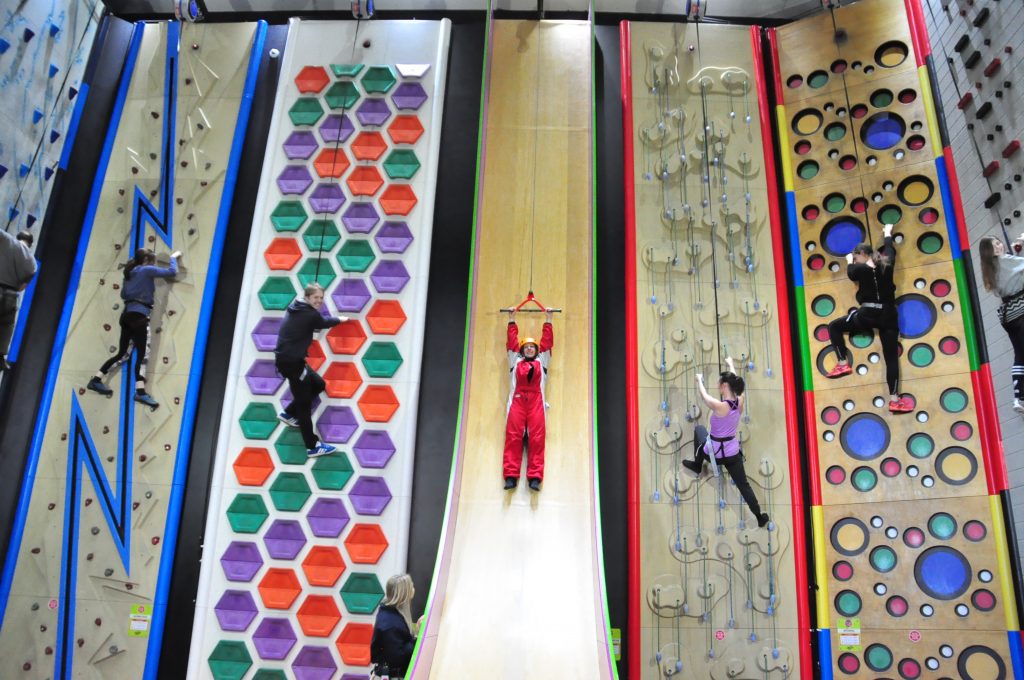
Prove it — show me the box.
[142,20,267,680]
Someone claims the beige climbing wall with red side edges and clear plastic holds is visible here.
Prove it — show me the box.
[623,23,811,679]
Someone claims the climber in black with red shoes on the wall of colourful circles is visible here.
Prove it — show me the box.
[827,224,913,413]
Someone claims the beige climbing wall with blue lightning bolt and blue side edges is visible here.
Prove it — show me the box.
[0,23,265,679]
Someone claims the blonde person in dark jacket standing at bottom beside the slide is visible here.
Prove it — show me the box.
[370,573,423,680]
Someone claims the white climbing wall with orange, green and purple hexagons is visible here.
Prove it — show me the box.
[189,20,450,680]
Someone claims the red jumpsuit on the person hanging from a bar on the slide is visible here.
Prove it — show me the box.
[503,322,555,479]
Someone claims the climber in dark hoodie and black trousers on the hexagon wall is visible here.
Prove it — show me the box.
[273,283,348,458]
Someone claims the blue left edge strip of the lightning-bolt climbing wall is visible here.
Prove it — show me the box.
[0,19,143,631]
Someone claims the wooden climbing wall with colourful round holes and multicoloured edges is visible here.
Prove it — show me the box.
[773,0,1022,678]
